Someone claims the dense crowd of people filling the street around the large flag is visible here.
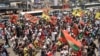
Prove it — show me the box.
[0,10,100,56]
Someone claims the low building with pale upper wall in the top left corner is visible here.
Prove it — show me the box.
[0,0,30,14]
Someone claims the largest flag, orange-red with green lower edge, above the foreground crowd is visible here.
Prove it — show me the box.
[62,30,82,51]
